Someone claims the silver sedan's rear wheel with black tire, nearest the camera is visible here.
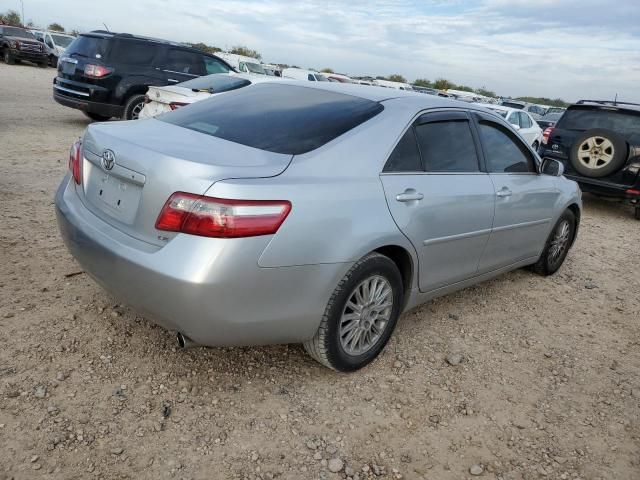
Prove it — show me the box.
[304,252,404,372]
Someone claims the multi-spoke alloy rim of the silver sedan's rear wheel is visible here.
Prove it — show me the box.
[338,275,393,356]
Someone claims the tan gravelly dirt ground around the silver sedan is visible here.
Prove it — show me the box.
[0,64,640,480]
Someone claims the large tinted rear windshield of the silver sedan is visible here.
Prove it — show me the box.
[158,83,384,155]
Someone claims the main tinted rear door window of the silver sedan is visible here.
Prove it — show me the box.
[416,120,479,172]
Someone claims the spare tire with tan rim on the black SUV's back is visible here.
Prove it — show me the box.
[569,128,629,178]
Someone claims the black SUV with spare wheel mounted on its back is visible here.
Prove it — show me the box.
[540,100,640,220]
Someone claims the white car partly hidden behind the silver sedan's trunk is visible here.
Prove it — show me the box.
[138,73,279,118]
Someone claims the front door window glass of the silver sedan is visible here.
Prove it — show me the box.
[479,120,536,173]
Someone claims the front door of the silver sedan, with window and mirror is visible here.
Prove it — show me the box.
[476,114,560,273]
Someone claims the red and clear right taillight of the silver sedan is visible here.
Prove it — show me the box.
[156,192,291,238]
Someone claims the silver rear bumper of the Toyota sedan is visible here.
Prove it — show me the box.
[55,175,351,346]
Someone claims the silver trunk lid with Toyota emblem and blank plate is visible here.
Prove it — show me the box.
[76,119,292,245]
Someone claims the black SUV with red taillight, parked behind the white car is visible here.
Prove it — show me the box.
[53,30,233,121]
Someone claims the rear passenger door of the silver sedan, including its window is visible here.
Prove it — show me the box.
[380,110,495,292]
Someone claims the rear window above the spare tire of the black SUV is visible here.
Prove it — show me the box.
[557,108,640,134]
